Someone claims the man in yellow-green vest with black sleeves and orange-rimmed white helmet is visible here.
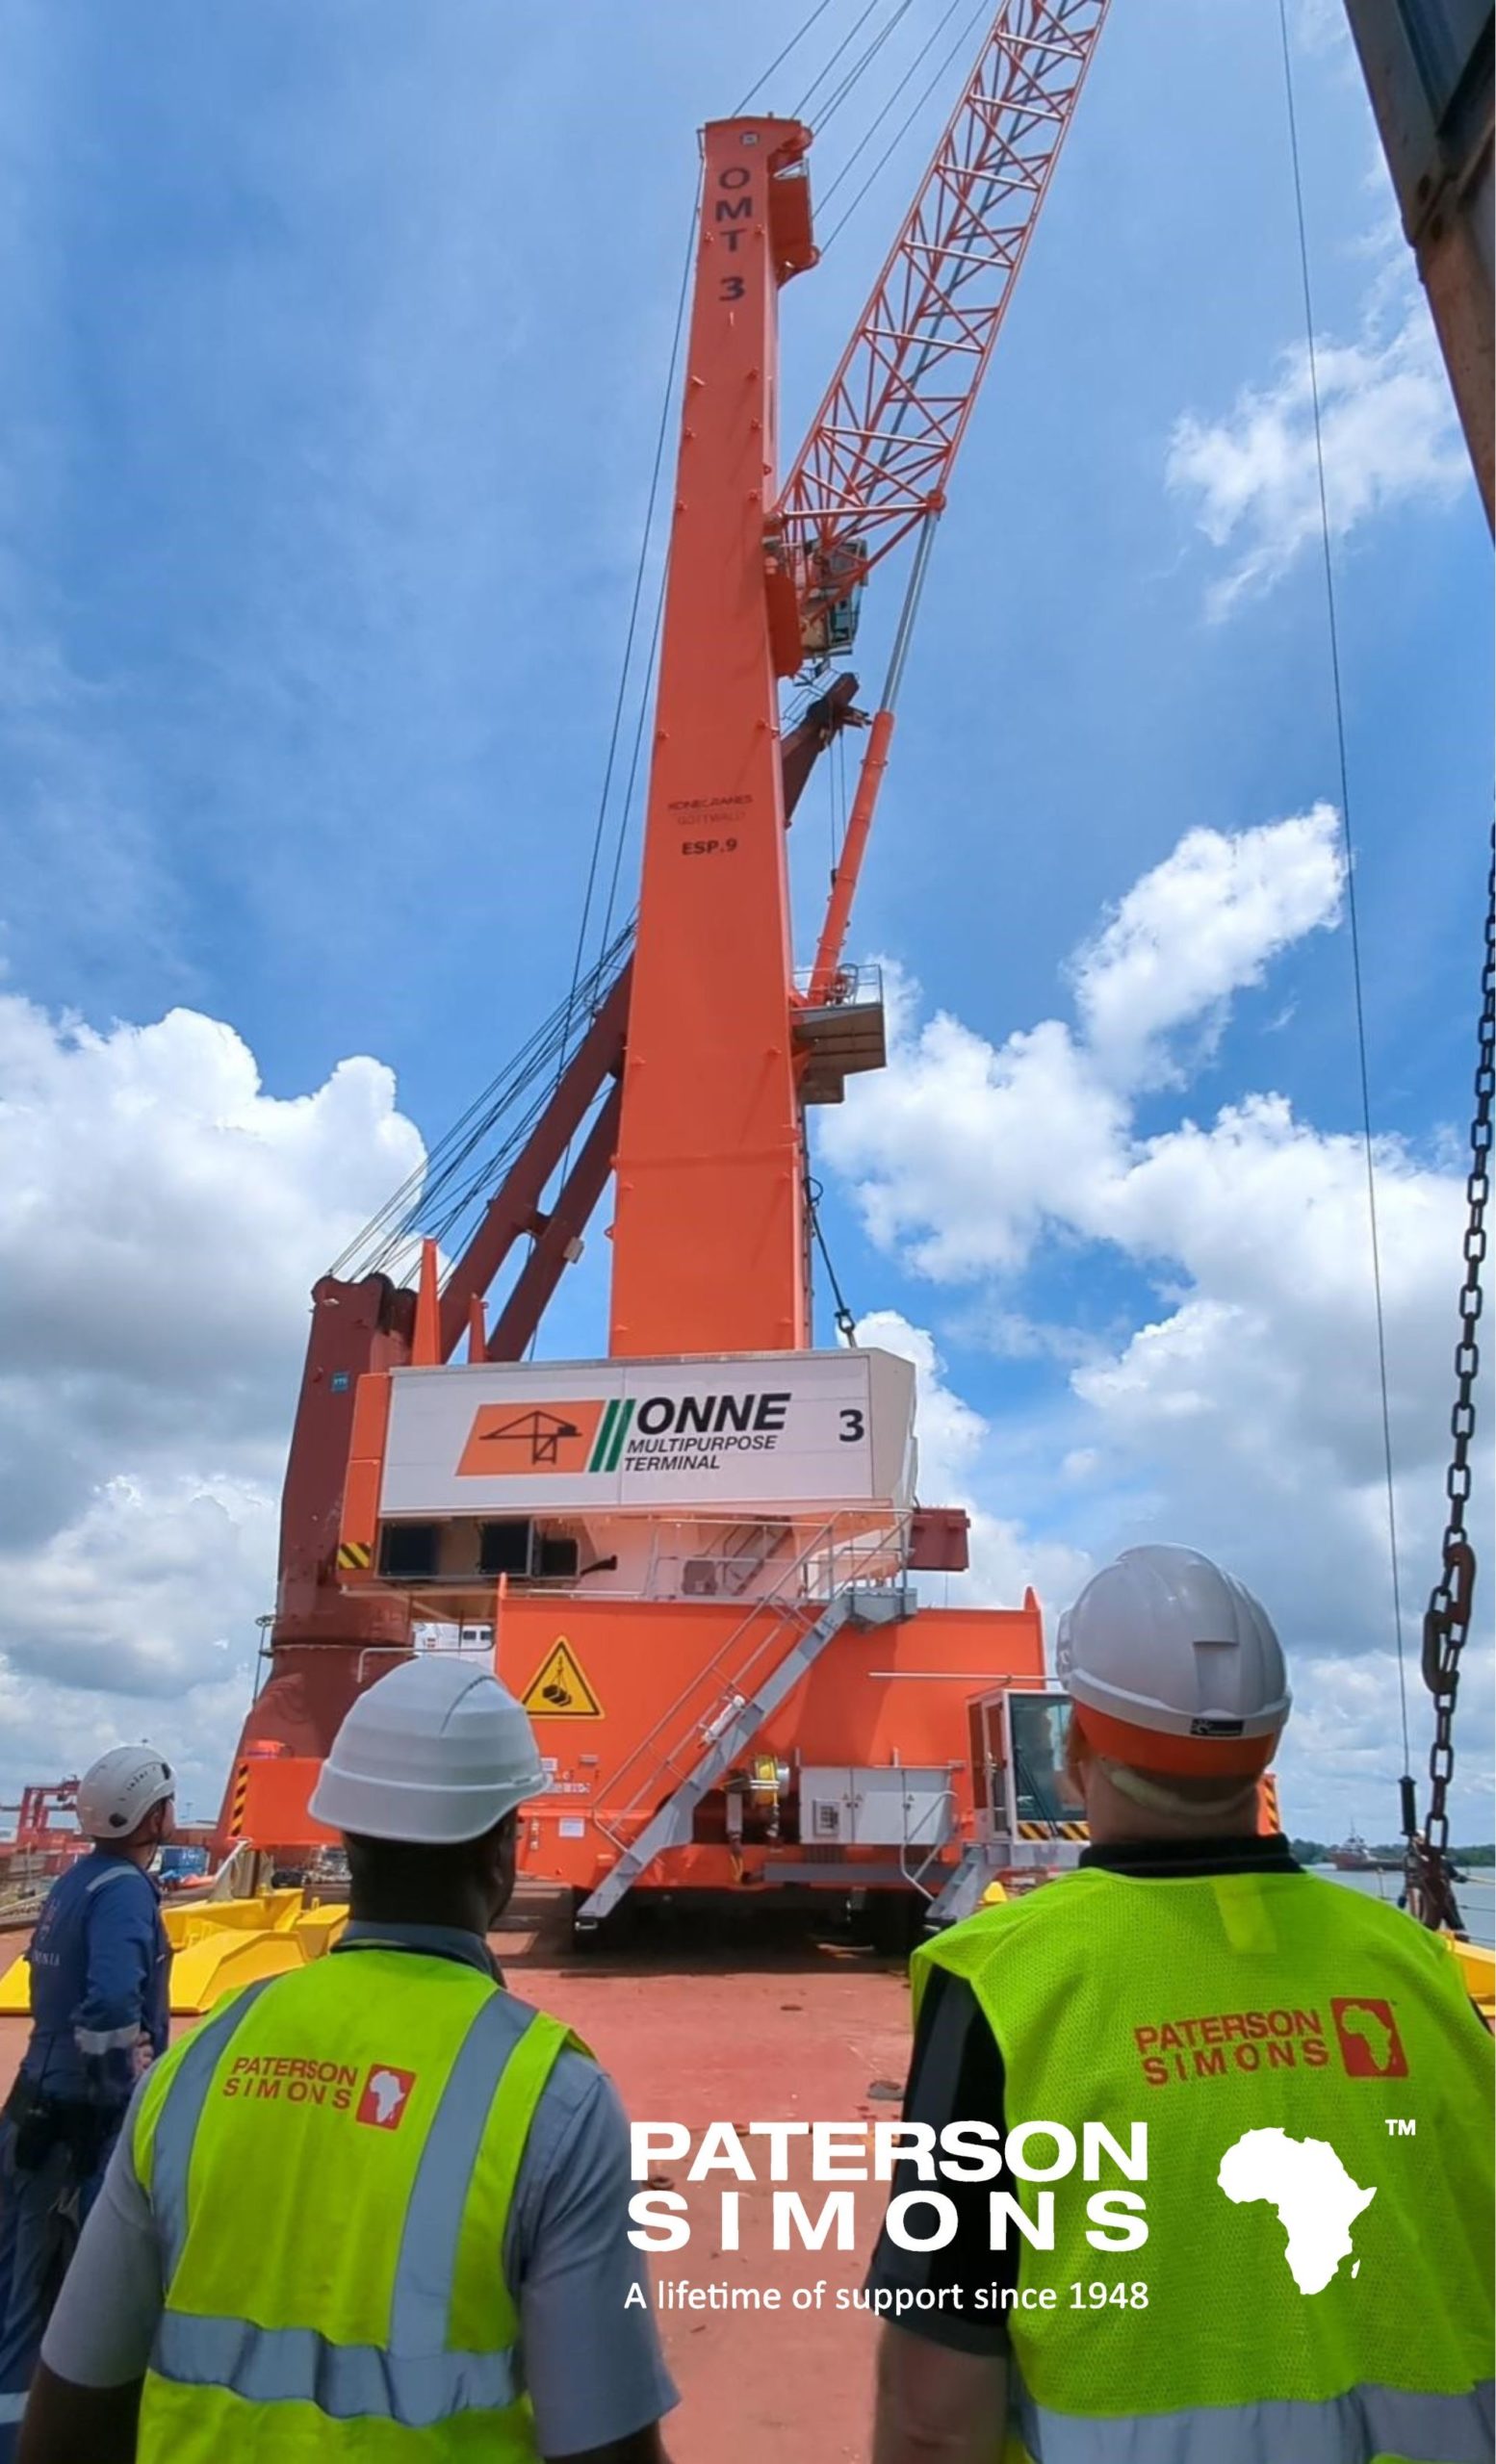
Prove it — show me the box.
[867,1548,1496,2464]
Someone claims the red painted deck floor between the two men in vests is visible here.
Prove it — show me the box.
[0,1892,910,2464]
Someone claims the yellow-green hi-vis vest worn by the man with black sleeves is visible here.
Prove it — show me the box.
[912,1867,1496,2464]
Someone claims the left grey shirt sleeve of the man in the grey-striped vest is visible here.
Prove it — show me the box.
[42,2090,163,2388]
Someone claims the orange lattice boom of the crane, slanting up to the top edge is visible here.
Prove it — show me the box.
[769,0,1109,675]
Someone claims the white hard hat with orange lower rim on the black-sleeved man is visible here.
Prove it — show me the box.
[1055,1545,1294,1774]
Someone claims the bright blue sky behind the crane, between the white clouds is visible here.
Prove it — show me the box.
[0,0,1491,1829]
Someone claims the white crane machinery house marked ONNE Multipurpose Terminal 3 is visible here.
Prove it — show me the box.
[343,1350,915,1624]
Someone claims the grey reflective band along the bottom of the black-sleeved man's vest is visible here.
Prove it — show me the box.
[1016,2380,1496,2464]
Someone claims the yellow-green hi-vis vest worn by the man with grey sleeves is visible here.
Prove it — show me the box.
[133,1949,586,2464]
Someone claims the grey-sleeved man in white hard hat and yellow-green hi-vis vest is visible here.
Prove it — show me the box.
[19,1656,675,2464]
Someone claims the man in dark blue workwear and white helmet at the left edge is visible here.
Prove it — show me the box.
[0,1744,172,2464]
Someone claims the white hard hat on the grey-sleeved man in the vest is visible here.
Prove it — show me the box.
[311,1654,545,1848]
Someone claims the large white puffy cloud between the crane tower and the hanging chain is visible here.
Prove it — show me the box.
[821,806,1488,1835]
